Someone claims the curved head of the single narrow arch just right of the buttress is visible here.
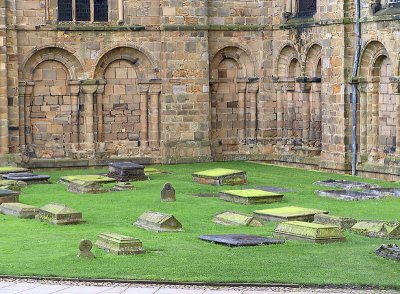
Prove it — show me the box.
[210,45,255,79]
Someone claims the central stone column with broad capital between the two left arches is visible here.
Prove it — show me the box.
[81,80,98,151]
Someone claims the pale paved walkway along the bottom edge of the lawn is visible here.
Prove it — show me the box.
[0,280,399,294]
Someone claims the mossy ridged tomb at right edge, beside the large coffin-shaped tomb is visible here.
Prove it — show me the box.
[350,220,400,239]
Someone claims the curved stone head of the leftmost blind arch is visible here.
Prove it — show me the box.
[21,47,83,80]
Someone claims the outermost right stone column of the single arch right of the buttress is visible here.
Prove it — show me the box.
[246,81,258,143]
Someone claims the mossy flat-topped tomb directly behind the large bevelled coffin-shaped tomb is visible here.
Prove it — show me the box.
[254,206,328,222]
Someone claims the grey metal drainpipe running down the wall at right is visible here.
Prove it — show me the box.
[351,0,361,176]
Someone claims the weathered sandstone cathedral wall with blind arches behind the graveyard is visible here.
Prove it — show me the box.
[0,0,400,179]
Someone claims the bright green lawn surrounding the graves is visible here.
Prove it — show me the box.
[0,162,400,288]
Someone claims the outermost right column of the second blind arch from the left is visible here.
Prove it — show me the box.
[149,83,161,149]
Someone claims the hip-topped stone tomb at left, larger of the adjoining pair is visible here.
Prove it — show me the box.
[35,203,85,225]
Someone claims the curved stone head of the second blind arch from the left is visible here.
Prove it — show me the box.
[93,46,157,80]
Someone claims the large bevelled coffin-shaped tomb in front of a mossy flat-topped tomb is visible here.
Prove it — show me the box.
[274,221,344,240]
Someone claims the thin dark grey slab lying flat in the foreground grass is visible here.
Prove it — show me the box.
[199,234,285,247]
